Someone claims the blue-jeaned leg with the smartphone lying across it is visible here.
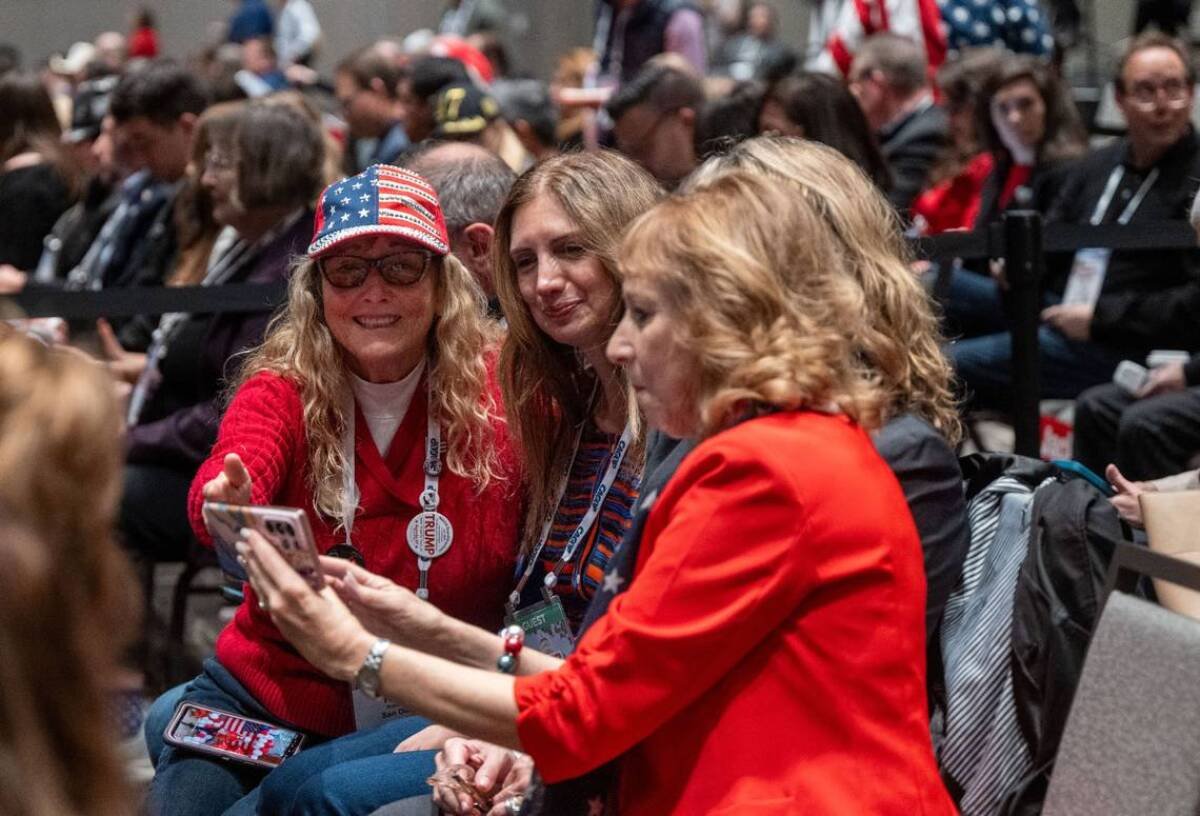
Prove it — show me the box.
[146,659,325,816]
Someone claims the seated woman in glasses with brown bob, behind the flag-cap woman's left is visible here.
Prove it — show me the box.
[117,102,324,573]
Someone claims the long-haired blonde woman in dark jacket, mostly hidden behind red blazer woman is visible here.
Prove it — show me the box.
[690,137,970,649]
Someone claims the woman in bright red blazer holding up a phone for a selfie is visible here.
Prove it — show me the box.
[240,173,953,816]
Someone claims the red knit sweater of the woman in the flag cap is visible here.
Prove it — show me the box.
[188,373,521,736]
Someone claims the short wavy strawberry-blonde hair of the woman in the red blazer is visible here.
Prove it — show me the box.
[620,170,887,437]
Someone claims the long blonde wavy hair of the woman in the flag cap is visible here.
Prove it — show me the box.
[235,254,502,518]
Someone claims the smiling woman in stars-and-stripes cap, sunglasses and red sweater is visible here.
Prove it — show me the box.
[148,164,522,815]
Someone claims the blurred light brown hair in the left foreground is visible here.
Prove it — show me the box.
[0,330,142,816]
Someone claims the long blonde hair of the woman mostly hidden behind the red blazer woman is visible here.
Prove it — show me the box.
[688,137,962,445]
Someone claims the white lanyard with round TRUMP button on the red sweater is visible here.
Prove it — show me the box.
[342,374,454,600]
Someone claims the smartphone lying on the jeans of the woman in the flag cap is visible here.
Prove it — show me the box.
[163,701,304,768]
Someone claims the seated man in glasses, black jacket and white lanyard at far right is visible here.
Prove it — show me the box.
[950,34,1200,409]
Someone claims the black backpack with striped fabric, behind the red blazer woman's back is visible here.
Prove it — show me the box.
[935,454,1129,816]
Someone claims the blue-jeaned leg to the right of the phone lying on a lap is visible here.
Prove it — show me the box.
[253,716,437,816]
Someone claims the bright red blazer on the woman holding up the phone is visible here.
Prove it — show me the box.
[515,412,954,816]
